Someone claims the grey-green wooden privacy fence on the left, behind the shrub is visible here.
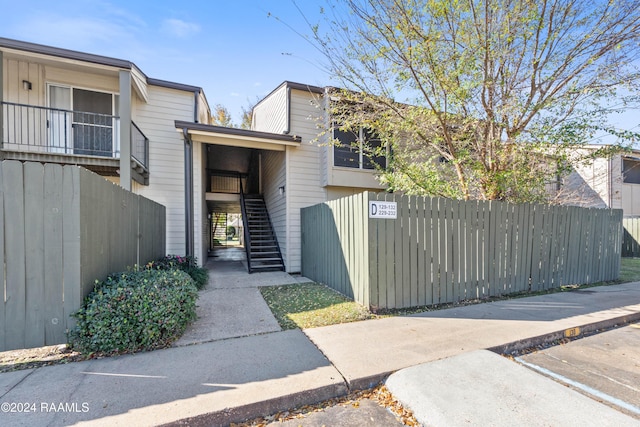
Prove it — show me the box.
[0,161,166,351]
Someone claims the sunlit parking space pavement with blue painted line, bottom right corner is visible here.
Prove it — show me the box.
[516,323,640,420]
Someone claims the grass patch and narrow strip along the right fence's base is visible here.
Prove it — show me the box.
[260,258,640,329]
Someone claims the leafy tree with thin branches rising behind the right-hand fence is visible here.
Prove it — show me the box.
[312,0,640,201]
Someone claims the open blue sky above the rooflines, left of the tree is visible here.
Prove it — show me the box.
[0,0,332,121]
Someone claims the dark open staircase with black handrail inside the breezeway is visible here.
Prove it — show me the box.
[244,195,284,273]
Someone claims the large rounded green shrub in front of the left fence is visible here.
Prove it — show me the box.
[69,269,198,353]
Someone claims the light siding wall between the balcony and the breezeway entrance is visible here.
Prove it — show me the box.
[135,86,194,255]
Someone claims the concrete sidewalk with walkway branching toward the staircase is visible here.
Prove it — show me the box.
[0,252,640,426]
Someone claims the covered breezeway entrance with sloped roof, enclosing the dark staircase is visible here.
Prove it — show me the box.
[176,122,300,272]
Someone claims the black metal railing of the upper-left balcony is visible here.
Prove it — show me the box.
[0,102,149,168]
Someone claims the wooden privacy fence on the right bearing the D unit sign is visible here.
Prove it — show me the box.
[302,193,622,309]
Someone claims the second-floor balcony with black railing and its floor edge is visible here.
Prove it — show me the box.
[0,102,149,184]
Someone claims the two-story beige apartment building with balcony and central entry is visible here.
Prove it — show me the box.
[0,38,384,272]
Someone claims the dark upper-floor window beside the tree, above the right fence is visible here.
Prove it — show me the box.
[333,127,387,170]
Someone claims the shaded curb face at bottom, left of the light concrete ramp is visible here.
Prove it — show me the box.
[161,382,349,427]
